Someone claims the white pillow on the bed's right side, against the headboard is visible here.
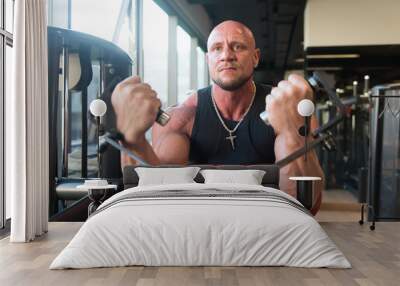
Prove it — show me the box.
[200,169,265,185]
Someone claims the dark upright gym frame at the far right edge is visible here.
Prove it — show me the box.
[360,84,400,230]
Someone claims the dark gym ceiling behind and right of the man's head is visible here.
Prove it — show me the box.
[188,0,400,85]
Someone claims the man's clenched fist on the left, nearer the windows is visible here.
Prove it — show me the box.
[111,76,161,145]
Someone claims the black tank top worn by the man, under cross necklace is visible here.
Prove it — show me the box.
[189,84,275,165]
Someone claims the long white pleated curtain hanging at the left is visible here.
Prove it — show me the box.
[6,0,49,242]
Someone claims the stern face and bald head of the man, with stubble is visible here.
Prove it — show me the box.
[207,24,259,90]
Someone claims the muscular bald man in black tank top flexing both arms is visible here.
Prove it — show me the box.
[112,21,324,214]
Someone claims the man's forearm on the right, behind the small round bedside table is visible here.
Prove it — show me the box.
[275,136,325,214]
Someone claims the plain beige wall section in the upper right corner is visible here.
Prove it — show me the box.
[304,0,400,48]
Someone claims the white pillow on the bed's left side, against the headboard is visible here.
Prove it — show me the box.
[135,167,200,186]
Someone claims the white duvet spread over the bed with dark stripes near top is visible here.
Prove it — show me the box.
[50,183,351,269]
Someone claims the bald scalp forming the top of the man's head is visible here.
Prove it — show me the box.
[207,20,256,50]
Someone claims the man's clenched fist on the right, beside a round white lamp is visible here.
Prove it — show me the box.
[266,74,313,137]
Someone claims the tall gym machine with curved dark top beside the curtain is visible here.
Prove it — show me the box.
[48,27,132,221]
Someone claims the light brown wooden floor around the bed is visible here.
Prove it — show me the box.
[0,219,400,286]
